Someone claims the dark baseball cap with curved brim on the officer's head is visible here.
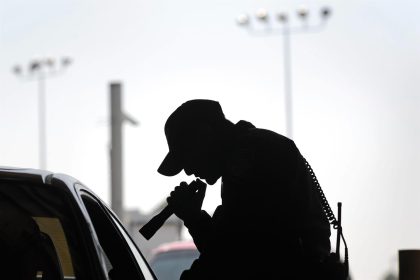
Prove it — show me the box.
[158,99,225,176]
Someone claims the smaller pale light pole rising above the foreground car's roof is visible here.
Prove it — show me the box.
[13,57,72,169]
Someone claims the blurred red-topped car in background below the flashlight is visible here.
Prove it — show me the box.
[150,240,200,280]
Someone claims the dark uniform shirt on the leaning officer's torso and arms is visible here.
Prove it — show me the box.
[181,121,330,279]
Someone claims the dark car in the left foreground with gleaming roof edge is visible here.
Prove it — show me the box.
[0,167,157,280]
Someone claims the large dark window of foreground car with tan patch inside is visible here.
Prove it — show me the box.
[0,181,97,280]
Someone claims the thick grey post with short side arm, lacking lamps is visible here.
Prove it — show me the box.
[110,82,138,223]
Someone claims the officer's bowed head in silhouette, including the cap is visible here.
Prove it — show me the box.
[158,99,227,184]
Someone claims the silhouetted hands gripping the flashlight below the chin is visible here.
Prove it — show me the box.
[166,179,207,223]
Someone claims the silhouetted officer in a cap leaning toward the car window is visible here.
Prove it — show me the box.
[158,100,330,279]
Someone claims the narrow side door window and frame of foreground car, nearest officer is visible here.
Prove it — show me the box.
[75,184,156,280]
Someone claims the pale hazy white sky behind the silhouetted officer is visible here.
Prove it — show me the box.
[0,0,420,280]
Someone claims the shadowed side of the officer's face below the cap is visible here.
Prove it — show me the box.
[183,126,223,185]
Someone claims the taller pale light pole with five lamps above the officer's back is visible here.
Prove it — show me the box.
[237,7,331,139]
